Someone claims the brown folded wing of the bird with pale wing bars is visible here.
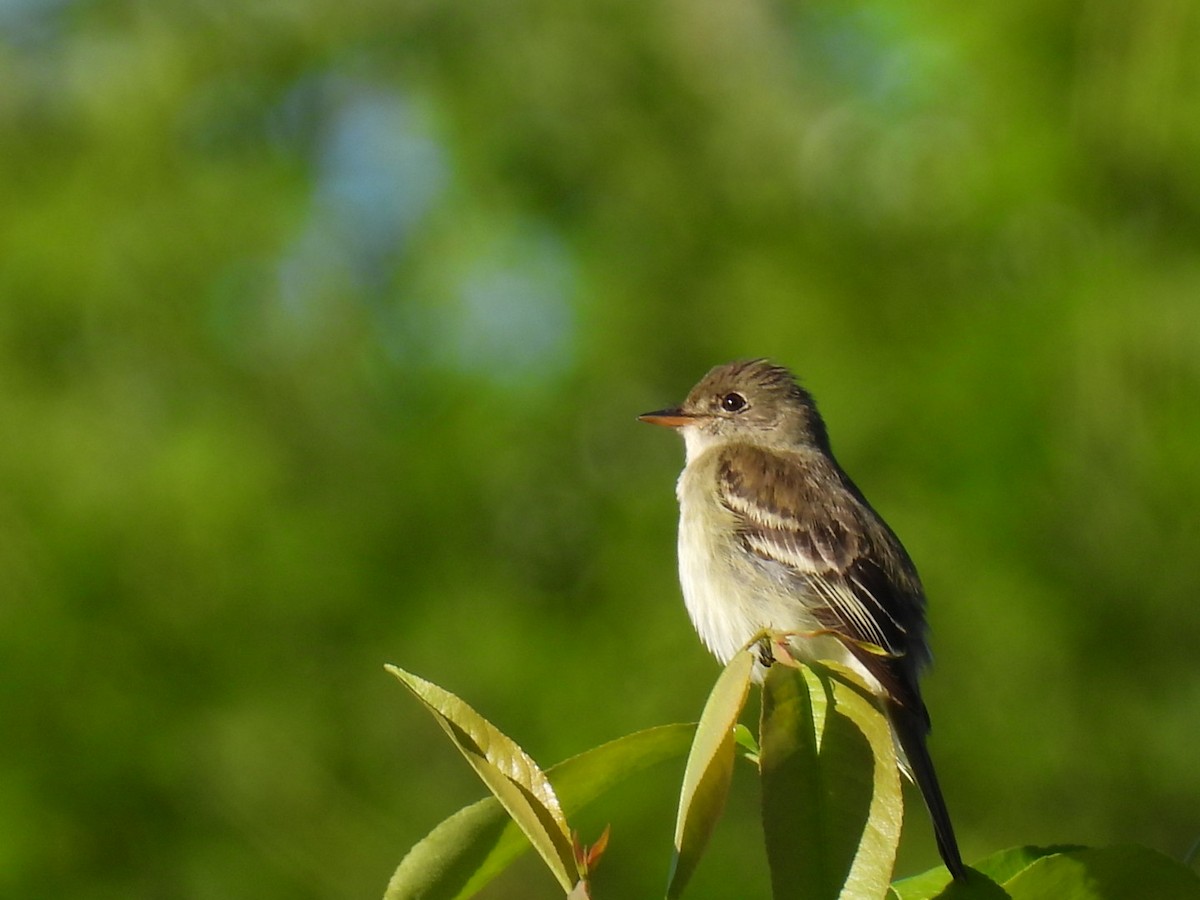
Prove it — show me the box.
[718,445,924,702]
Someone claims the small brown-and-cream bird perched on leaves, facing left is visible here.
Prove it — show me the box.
[638,359,967,880]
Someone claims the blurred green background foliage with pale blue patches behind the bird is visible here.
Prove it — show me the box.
[0,0,1200,900]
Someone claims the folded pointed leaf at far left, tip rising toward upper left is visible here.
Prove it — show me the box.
[386,666,580,892]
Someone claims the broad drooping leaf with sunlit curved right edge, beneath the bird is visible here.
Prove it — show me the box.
[760,665,904,900]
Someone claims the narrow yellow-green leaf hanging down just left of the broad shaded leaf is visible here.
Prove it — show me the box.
[667,650,755,899]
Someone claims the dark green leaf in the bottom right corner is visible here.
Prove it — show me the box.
[1004,845,1200,900]
